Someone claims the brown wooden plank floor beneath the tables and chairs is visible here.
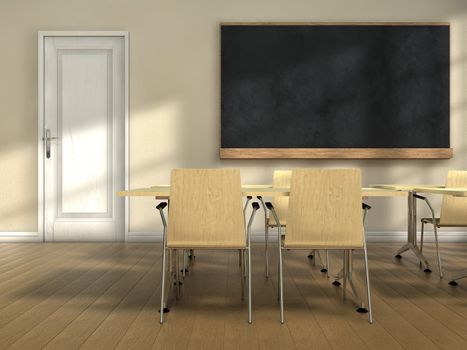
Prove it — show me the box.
[0,243,467,350]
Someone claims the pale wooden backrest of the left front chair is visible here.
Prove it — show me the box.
[167,169,246,248]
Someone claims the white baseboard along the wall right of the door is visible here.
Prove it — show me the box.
[127,231,467,243]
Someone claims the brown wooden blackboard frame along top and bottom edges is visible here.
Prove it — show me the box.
[219,22,453,159]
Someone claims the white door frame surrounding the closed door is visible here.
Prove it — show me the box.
[37,31,130,242]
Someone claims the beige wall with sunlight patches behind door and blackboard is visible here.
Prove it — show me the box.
[0,0,467,238]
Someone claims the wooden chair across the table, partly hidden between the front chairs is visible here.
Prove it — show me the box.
[258,170,329,278]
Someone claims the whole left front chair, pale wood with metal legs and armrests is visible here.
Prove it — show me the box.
[156,169,259,324]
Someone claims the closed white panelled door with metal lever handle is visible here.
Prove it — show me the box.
[43,36,126,241]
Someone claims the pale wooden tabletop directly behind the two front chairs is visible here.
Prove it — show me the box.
[117,185,407,197]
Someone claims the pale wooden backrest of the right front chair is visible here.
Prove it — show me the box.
[284,169,364,249]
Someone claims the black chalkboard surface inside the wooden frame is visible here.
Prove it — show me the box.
[221,24,450,148]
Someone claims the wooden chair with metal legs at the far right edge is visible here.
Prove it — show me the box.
[415,170,467,286]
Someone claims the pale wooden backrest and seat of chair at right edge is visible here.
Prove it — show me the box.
[439,170,467,226]
